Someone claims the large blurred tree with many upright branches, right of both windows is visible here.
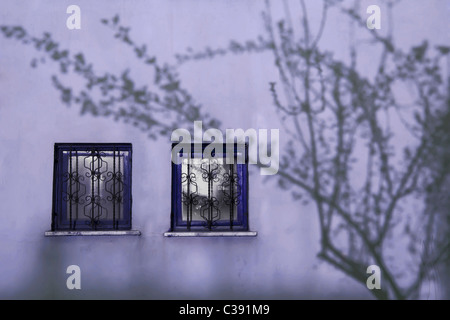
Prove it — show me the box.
[264,0,450,299]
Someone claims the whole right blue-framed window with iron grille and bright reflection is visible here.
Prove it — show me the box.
[171,143,249,231]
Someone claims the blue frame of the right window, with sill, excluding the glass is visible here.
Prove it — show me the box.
[171,143,251,232]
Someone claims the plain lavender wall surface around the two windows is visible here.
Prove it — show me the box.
[0,0,449,299]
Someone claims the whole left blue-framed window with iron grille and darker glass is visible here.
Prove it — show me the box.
[51,143,132,231]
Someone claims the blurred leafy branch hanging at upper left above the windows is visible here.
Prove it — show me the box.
[0,16,220,139]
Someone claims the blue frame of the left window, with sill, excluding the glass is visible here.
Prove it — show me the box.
[50,143,133,231]
